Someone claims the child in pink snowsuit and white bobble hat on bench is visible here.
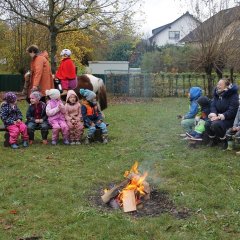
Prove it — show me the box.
[46,89,69,145]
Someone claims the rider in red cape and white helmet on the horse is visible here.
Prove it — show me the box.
[55,49,77,95]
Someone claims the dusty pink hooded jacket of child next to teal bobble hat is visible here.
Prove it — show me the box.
[65,90,82,125]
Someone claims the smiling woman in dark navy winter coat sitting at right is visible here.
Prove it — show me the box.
[205,79,239,149]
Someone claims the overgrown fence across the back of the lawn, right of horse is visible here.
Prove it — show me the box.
[105,72,240,97]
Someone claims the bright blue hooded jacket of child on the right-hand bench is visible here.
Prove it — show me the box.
[184,87,202,119]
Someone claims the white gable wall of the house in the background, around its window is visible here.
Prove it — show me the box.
[153,16,197,46]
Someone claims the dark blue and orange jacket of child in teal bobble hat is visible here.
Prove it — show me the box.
[81,100,103,127]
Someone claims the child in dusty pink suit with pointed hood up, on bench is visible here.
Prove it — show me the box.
[65,90,84,145]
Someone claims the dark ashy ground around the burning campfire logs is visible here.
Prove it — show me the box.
[89,189,190,219]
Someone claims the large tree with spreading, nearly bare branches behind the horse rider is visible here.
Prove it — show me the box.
[0,0,142,71]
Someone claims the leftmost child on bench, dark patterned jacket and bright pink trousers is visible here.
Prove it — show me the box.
[0,92,28,149]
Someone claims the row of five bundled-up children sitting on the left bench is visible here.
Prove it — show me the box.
[0,89,108,149]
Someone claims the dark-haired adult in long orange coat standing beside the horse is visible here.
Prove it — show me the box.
[27,45,54,102]
